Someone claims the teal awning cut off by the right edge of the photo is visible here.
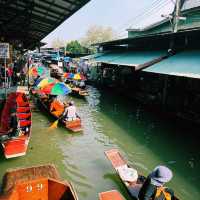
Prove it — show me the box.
[143,50,200,78]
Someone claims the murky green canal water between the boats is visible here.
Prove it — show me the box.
[0,87,200,200]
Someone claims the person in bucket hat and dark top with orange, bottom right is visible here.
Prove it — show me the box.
[138,166,175,200]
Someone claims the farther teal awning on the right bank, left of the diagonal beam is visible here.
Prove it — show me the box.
[95,51,167,66]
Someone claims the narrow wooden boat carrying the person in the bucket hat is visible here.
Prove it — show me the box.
[105,149,178,200]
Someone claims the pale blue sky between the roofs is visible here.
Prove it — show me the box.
[42,0,174,47]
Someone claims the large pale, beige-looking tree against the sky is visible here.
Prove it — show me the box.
[81,26,117,51]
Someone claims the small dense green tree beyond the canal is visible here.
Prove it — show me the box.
[66,40,87,54]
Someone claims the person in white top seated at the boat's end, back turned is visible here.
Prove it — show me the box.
[63,101,77,121]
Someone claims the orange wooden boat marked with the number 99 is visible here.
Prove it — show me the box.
[0,165,78,200]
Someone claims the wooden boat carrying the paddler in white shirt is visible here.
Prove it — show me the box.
[36,94,83,132]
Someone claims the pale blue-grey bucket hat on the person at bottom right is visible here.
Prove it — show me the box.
[149,166,173,186]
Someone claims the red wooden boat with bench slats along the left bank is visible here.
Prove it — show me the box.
[0,92,32,158]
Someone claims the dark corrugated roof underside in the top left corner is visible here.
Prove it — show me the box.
[0,0,90,48]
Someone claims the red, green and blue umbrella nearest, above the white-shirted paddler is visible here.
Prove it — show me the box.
[41,82,71,95]
